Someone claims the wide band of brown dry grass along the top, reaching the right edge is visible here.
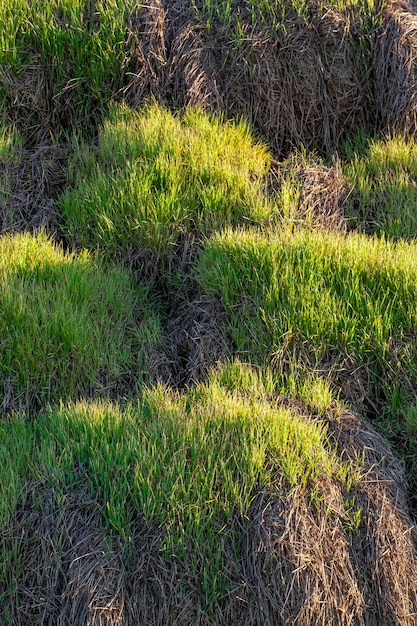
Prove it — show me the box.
[124,0,417,155]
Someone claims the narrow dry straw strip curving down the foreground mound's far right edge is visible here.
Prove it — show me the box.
[324,412,417,626]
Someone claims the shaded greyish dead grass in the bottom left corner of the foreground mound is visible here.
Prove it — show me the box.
[0,484,125,626]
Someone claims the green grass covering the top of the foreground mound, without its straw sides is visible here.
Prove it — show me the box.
[0,364,349,604]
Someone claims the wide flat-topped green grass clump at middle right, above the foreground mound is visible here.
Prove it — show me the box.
[199,225,417,414]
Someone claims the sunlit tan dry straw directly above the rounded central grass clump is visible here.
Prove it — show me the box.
[123,0,223,111]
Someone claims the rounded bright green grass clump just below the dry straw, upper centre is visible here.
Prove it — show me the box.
[61,105,273,257]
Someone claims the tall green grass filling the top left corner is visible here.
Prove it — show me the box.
[0,0,136,134]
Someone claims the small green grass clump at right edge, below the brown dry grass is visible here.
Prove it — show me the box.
[344,137,417,239]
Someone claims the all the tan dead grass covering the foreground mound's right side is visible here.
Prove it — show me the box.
[234,399,417,626]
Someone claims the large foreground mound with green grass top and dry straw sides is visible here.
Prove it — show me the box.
[0,363,417,625]
